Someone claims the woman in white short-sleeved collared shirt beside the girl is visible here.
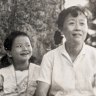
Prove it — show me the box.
[36,6,96,96]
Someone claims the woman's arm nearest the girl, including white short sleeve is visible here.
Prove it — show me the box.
[35,52,53,96]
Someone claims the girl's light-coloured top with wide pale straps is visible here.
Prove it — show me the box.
[0,63,39,96]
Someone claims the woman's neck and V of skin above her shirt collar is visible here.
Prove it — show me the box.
[65,43,83,61]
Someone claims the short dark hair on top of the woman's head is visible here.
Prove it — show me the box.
[56,6,92,30]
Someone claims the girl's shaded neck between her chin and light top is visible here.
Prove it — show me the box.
[13,61,29,71]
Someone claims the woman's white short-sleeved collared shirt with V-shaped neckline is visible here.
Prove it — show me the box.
[38,44,96,96]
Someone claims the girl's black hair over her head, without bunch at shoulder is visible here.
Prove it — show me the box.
[4,31,29,51]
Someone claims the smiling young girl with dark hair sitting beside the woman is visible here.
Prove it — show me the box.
[0,31,39,96]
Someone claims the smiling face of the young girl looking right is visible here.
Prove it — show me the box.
[10,36,32,61]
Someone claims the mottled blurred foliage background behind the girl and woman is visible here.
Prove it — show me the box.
[0,0,96,64]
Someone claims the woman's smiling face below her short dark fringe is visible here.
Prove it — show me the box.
[62,12,88,44]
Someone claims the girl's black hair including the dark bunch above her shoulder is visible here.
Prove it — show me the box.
[0,31,29,68]
